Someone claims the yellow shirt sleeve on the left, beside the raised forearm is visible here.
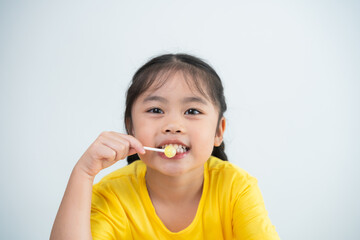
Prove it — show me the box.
[90,184,128,240]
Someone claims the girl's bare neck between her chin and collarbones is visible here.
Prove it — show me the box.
[145,168,204,204]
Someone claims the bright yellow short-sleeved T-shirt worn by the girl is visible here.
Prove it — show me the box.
[91,157,279,240]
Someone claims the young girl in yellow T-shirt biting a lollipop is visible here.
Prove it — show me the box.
[50,54,279,240]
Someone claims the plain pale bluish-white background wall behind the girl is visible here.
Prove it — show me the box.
[0,0,360,240]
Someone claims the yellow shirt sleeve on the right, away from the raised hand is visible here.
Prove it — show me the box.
[233,177,280,240]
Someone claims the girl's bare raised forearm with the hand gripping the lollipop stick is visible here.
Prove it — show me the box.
[50,132,145,240]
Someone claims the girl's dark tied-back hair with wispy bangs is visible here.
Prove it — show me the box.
[124,54,227,164]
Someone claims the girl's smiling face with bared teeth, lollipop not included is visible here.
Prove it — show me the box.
[131,73,225,176]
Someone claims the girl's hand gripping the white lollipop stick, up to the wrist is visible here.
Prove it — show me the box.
[76,131,145,177]
